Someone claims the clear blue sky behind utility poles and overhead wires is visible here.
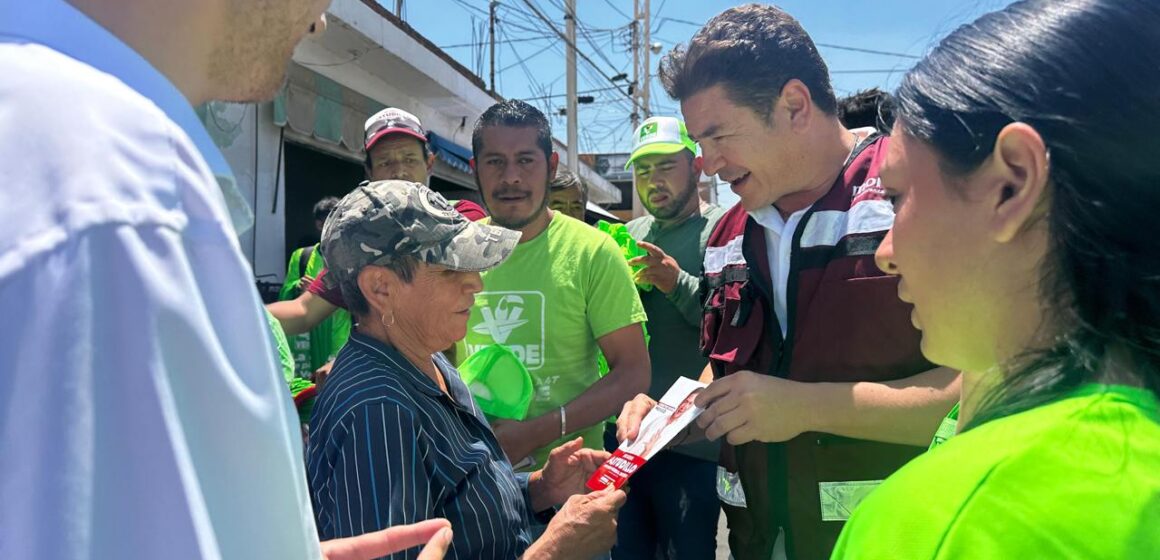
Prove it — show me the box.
[380,0,1010,202]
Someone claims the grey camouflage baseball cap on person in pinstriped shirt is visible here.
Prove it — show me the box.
[322,181,520,282]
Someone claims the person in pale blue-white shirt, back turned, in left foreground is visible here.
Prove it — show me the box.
[0,0,450,559]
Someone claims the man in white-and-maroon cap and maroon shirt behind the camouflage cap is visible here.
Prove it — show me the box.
[267,107,487,383]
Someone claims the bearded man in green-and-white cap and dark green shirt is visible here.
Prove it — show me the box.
[612,117,724,559]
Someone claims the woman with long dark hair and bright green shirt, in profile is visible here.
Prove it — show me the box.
[834,0,1160,559]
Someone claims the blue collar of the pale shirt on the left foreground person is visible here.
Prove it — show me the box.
[0,0,253,233]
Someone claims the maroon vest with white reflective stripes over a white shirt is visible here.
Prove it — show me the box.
[701,136,933,560]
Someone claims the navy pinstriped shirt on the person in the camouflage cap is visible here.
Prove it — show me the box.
[306,334,531,560]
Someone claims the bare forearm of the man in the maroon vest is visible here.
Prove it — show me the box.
[798,368,959,445]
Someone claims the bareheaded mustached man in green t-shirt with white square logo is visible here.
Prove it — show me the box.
[457,101,650,470]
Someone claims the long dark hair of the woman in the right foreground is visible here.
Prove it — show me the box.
[896,0,1160,429]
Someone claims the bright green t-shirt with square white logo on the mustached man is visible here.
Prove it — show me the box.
[456,212,645,468]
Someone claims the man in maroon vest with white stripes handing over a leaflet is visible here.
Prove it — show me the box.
[618,3,958,560]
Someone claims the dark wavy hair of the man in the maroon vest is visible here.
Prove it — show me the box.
[660,3,838,119]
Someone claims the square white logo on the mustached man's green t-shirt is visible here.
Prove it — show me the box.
[465,291,545,370]
